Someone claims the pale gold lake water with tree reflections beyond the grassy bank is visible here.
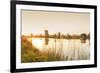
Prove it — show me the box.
[32,38,90,60]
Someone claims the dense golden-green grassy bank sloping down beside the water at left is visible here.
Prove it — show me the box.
[21,37,62,63]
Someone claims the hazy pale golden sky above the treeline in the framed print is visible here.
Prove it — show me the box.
[21,10,90,35]
